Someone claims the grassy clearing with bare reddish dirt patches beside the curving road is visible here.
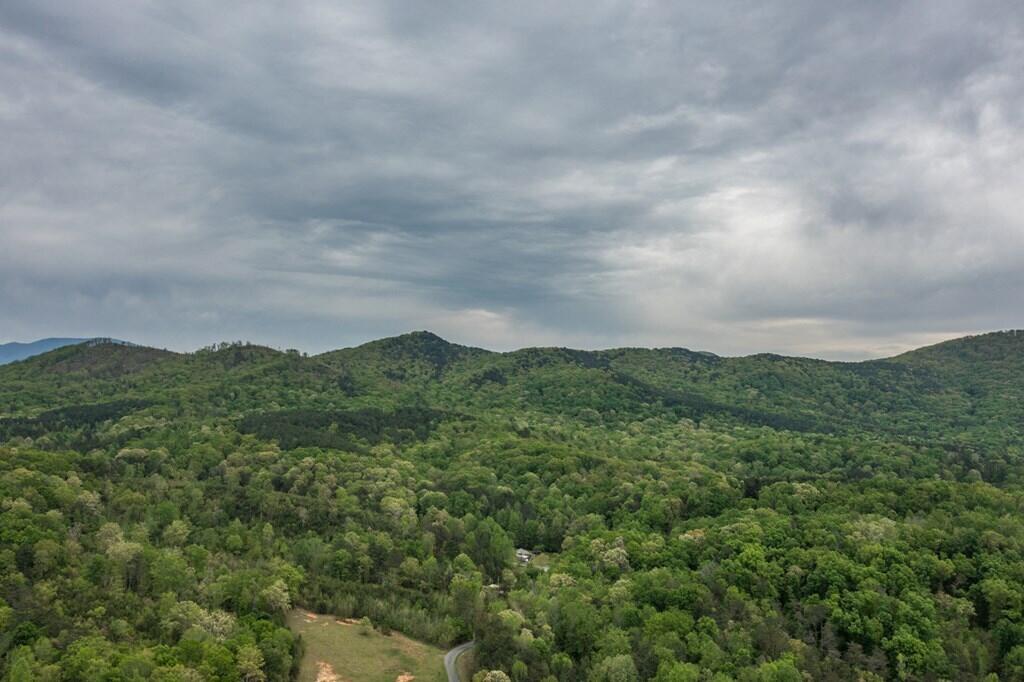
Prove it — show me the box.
[288,609,447,682]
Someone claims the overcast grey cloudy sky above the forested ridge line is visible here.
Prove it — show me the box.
[0,0,1024,359]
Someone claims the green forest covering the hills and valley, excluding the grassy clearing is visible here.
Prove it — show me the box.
[0,332,1024,682]
